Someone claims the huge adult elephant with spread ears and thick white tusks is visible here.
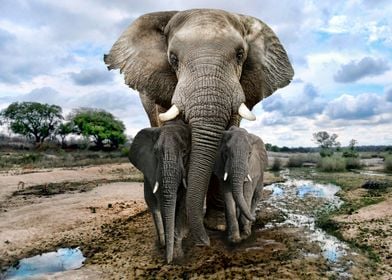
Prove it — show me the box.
[104,9,294,245]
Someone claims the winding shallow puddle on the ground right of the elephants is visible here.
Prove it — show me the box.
[259,173,350,277]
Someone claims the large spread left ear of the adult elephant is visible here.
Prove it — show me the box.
[104,11,177,105]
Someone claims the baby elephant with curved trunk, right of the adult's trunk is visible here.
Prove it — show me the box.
[215,126,268,243]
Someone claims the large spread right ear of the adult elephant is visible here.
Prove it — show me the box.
[240,15,294,108]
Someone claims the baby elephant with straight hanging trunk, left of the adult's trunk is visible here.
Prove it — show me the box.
[129,120,191,263]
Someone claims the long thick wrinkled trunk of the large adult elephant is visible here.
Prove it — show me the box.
[177,55,244,245]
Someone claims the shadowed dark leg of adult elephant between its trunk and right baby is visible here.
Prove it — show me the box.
[204,174,226,231]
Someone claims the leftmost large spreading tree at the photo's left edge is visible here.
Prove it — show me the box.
[0,102,63,144]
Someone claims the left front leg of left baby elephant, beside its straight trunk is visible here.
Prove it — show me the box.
[144,179,165,246]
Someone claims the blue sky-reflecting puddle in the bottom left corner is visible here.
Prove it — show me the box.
[4,248,86,280]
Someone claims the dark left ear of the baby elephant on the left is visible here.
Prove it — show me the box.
[128,128,161,180]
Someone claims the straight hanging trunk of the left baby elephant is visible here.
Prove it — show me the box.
[161,161,182,263]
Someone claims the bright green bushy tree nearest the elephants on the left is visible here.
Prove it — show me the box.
[69,108,126,149]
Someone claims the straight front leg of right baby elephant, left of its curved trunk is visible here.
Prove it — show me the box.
[224,191,241,243]
